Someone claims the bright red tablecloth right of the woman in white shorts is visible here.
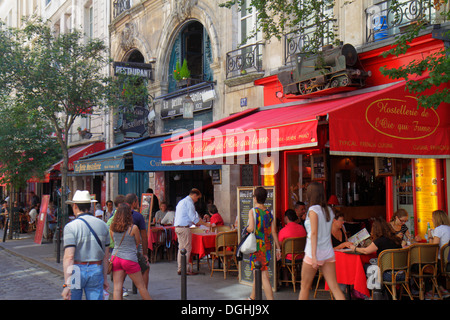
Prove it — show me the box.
[325,251,376,297]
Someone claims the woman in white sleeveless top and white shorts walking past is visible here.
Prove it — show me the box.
[299,182,345,300]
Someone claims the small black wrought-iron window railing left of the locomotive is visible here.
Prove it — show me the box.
[226,43,263,79]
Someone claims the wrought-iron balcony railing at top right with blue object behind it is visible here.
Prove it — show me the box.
[365,0,443,42]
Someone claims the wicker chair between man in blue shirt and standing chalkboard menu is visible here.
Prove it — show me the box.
[210,230,238,279]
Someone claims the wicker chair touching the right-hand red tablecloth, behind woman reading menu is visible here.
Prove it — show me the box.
[378,248,413,300]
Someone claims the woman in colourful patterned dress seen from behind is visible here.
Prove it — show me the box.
[247,187,281,300]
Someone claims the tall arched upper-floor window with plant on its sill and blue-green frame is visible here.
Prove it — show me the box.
[168,21,213,92]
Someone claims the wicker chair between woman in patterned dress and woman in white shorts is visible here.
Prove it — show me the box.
[280,237,306,292]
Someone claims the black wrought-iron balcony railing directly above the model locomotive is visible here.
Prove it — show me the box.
[284,20,335,65]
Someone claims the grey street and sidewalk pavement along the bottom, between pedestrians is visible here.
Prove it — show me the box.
[0,230,330,301]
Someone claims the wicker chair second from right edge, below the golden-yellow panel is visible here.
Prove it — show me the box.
[409,243,442,300]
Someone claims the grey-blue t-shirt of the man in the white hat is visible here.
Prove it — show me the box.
[64,213,110,262]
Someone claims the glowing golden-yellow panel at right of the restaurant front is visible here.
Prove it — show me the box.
[414,159,438,238]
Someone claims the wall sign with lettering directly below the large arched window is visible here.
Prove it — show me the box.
[161,86,215,119]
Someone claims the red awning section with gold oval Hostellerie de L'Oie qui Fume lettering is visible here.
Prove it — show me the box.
[329,82,450,158]
